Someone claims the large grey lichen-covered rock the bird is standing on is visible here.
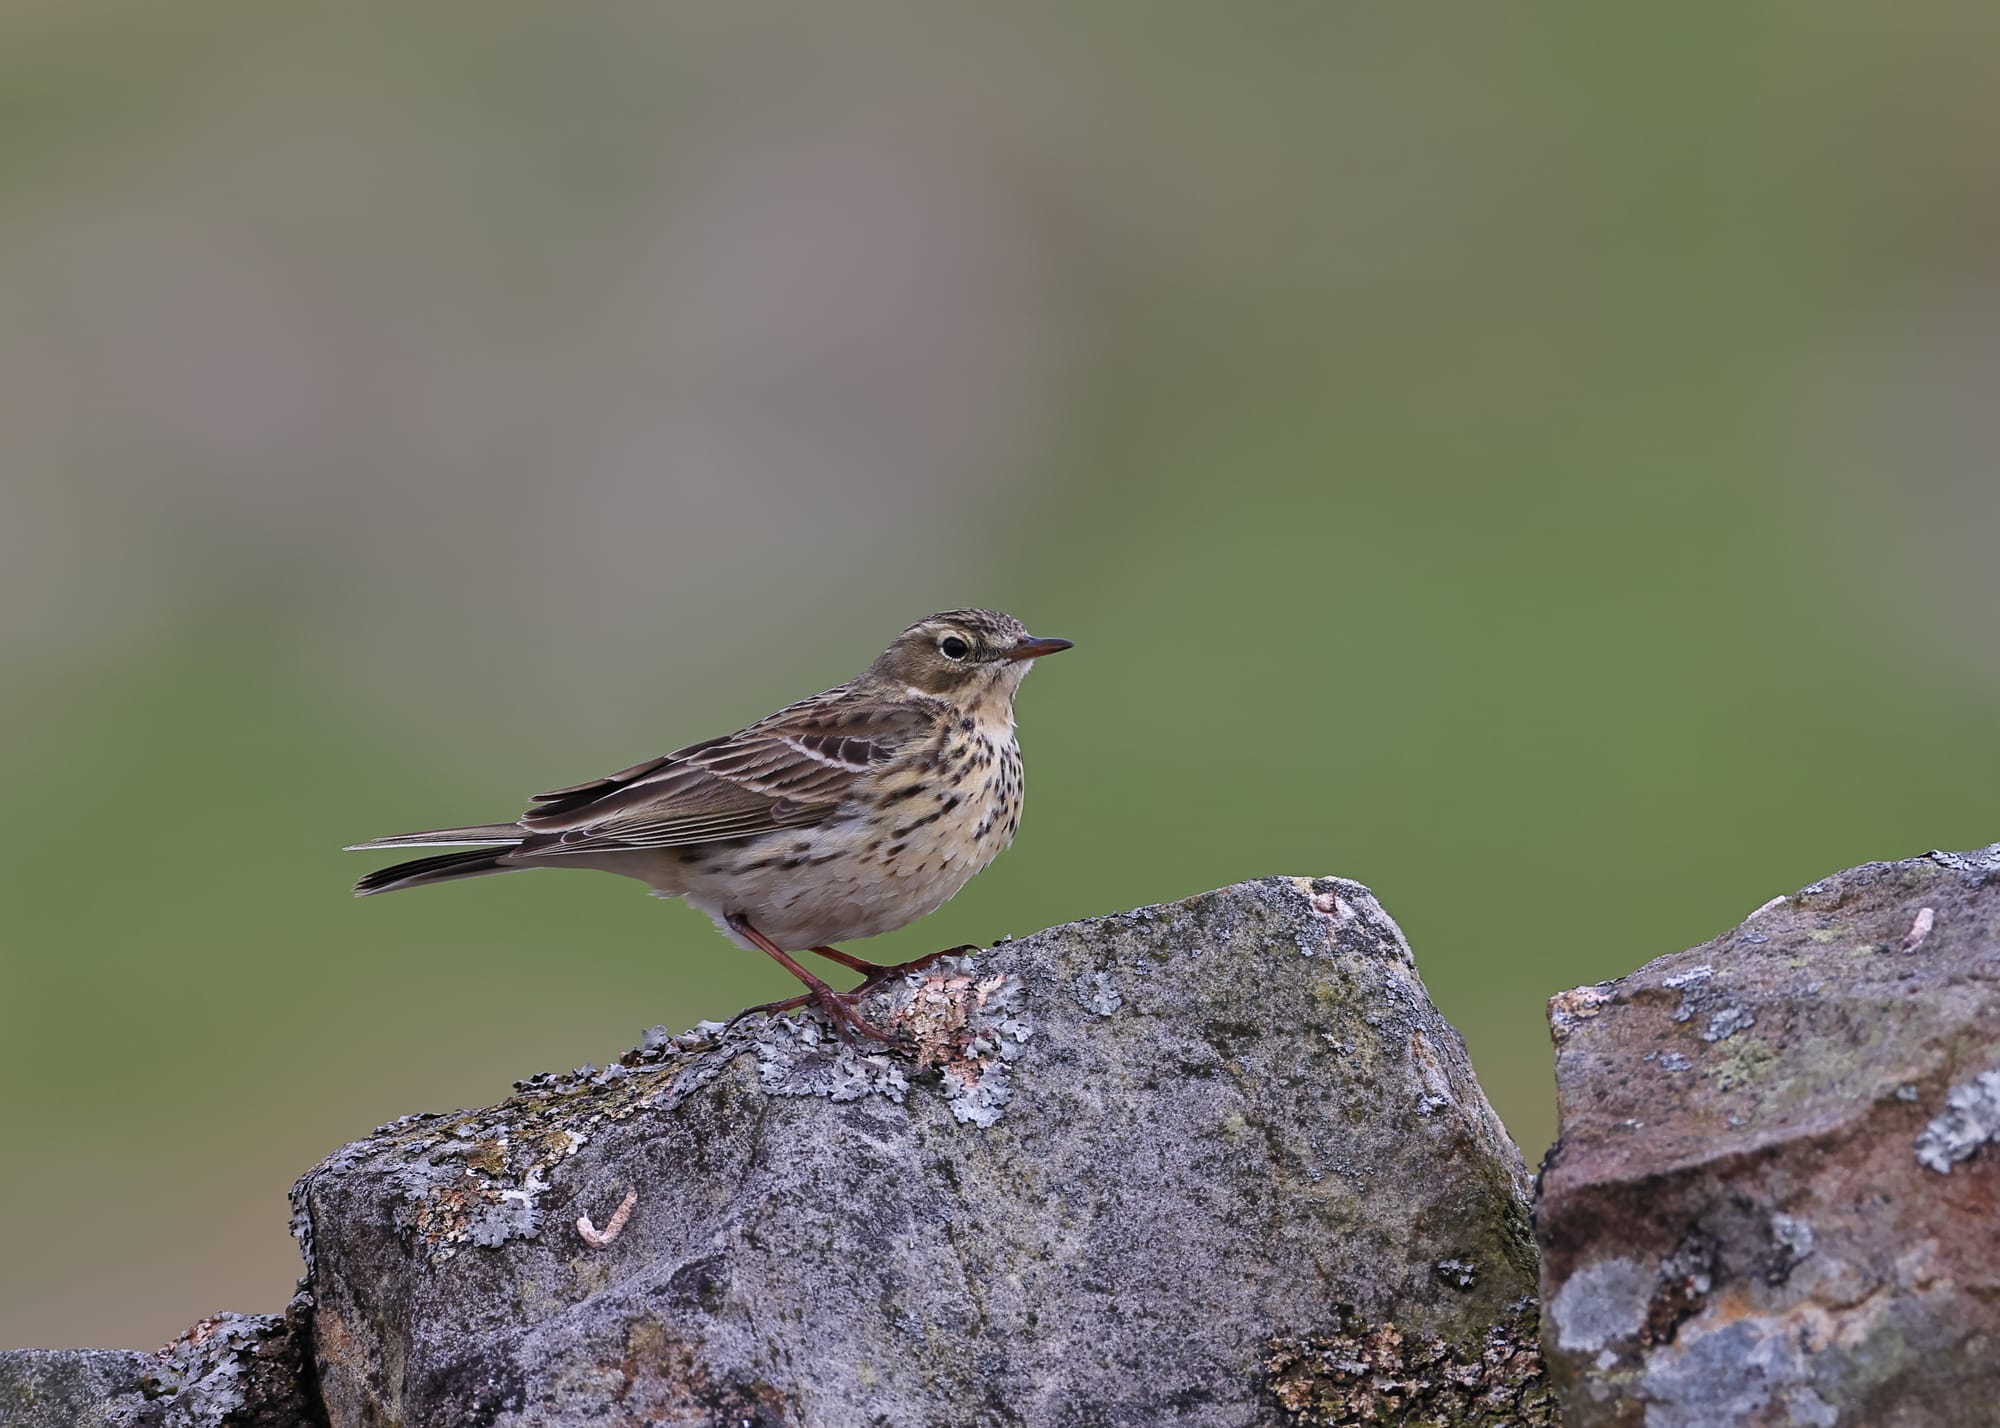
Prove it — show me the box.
[294,878,1548,1428]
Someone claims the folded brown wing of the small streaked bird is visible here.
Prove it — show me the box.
[508,688,936,856]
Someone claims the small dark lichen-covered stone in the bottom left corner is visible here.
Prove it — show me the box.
[0,1302,324,1428]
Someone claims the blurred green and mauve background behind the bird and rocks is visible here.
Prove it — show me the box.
[0,0,2000,1346]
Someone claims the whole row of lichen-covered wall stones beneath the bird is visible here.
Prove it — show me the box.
[0,844,2000,1428]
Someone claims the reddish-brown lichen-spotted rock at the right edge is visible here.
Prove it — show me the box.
[1536,844,2000,1428]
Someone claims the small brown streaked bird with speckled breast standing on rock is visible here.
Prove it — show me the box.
[348,610,1072,1044]
